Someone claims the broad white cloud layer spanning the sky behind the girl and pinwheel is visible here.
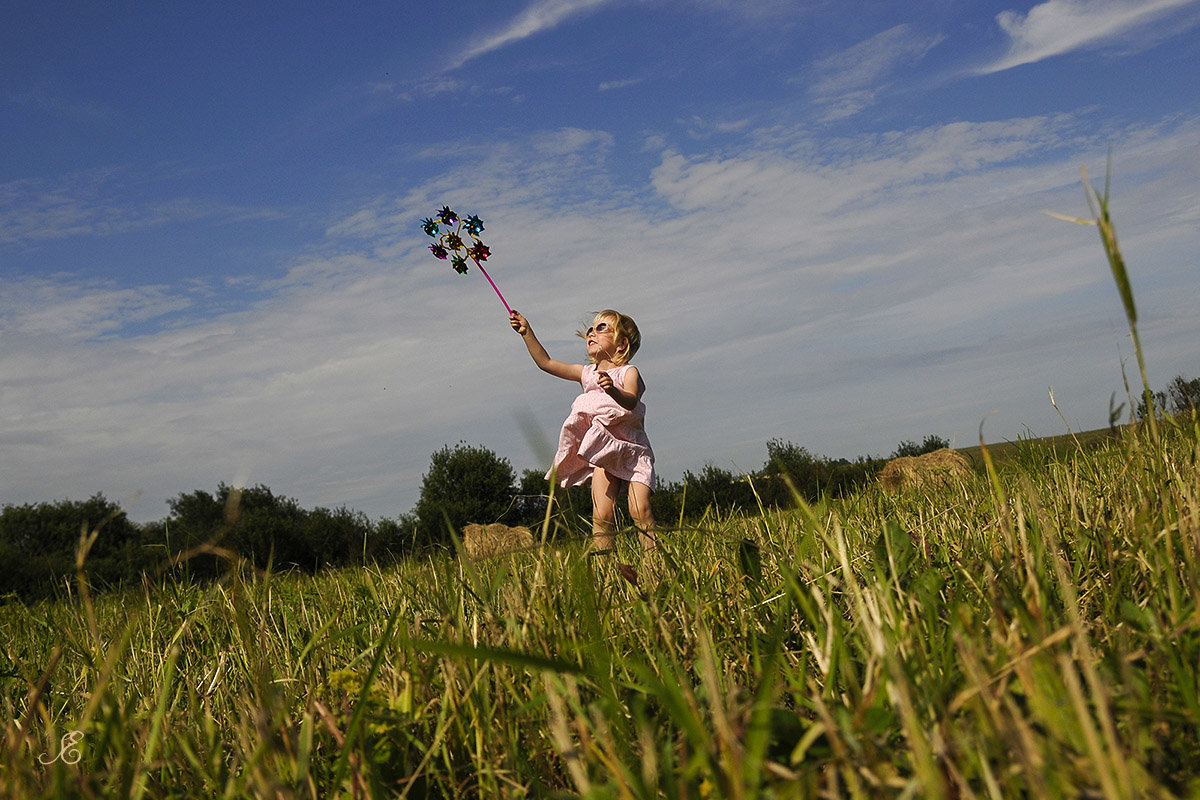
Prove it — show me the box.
[0,115,1200,519]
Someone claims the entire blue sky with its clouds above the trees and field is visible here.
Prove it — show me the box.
[0,0,1200,521]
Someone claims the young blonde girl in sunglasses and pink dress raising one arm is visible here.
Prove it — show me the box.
[509,309,654,552]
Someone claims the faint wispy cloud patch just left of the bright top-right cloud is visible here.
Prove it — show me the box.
[809,23,943,120]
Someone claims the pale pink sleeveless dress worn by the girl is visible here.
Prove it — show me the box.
[546,363,654,489]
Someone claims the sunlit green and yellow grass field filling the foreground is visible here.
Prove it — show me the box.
[0,412,1200,798]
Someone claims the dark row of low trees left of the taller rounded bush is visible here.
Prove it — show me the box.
[0,483,404,602]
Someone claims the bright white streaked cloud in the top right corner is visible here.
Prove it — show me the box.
[979,0,1195,74]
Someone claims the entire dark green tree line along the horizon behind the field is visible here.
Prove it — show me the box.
[0,377,1200,602]
